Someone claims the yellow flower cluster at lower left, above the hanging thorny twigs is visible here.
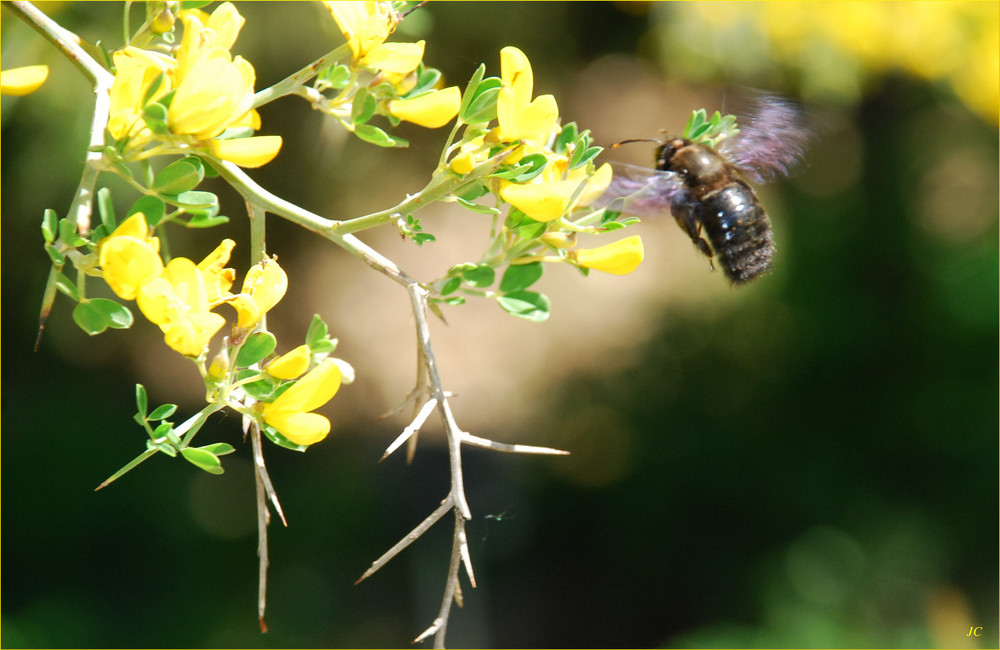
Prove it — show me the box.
[98,212,351,447]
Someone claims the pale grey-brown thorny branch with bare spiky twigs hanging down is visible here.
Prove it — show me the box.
[13,1,580,648]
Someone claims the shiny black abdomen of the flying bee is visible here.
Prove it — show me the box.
[699,180,774,284]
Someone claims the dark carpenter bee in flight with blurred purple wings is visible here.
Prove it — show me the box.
[601,95,810,285]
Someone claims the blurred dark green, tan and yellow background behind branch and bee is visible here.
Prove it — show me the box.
[0,2,1000,647]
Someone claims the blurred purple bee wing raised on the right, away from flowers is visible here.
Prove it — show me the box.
[717,94,812,183]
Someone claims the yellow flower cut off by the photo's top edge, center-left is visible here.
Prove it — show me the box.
[323,2,424,74]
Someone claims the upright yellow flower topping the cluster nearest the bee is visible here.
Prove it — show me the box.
[497,47,559,142]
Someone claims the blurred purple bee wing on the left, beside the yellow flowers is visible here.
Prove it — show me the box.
[593,162,684,217]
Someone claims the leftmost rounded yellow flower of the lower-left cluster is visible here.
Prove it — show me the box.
[98,212,163,300]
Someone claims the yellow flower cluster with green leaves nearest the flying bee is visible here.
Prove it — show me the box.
[441,47,643,319]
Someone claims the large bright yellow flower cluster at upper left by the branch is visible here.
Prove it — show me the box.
[108,2,281,167]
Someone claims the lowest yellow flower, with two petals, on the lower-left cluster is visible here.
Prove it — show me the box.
[261,359,341,445]
